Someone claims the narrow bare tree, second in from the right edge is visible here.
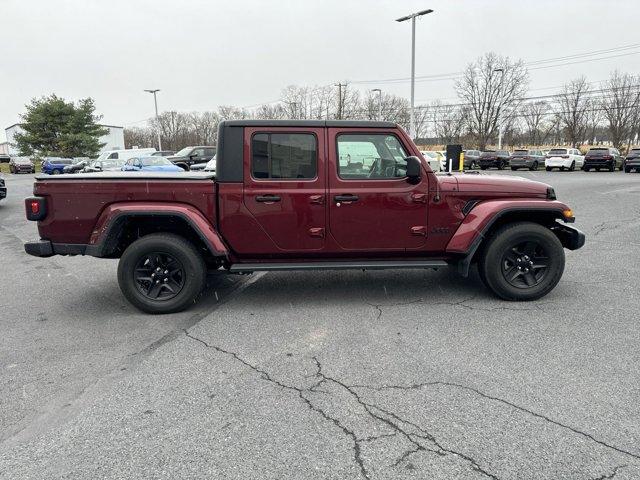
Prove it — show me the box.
[558,77,593,148]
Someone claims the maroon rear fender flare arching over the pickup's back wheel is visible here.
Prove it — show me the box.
[85,202,229,258]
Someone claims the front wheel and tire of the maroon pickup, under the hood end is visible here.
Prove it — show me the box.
[478,222,565,301]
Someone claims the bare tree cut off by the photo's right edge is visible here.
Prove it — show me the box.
[600,71,640,149]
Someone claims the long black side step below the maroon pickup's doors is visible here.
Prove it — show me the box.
[229,260,449,272]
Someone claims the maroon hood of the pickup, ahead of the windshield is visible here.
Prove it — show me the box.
[444,174,551,198]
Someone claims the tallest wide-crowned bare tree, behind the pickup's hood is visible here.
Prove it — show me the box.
[456,53,529,149]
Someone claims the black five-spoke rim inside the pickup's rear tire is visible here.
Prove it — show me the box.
[133,252,185,300]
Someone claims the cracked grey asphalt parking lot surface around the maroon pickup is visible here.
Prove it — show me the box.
[0,171,640,480]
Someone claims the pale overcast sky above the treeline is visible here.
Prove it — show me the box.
[0,0,640,136]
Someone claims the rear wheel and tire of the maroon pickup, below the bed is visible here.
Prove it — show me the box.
[118,233,207,314]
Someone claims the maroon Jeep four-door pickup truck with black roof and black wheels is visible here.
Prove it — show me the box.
[25,120,585,313]
